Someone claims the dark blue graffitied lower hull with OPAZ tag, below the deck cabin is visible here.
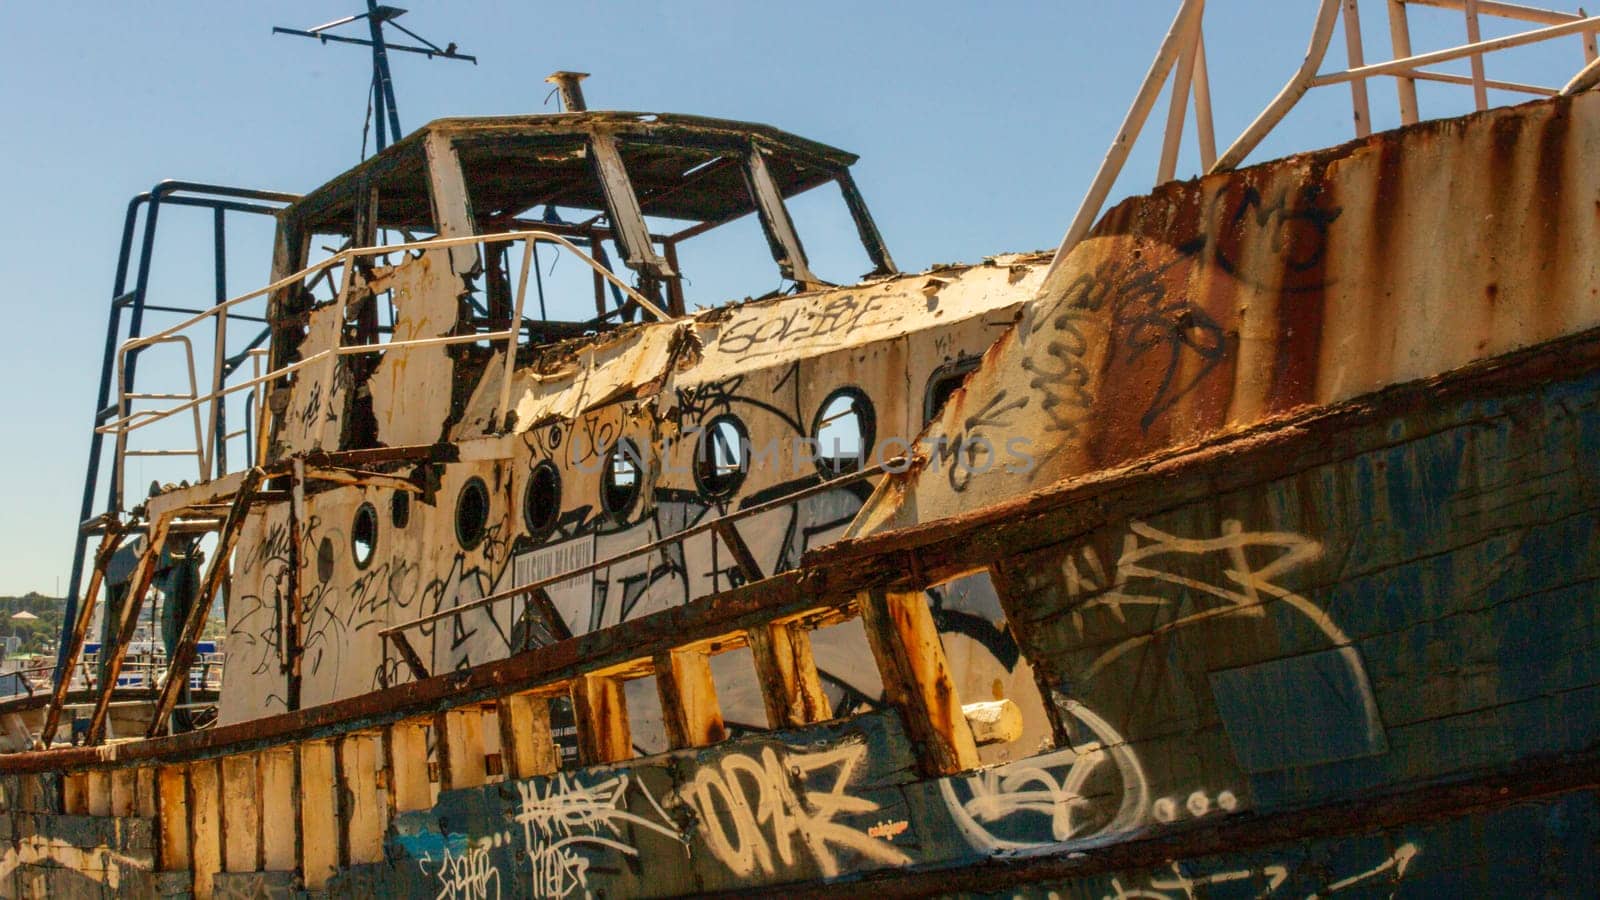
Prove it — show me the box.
[0,313,1600,897]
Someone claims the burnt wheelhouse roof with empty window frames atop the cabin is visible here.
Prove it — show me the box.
[275,112,896,338]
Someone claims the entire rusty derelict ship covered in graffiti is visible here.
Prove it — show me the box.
[0,0,1600,897]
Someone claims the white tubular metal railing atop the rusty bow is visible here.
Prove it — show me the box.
[1045,0,1600,283]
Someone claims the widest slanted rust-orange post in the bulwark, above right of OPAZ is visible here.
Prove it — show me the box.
[856,591,979,775]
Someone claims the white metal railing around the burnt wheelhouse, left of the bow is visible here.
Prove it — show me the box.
[96,231,670,496]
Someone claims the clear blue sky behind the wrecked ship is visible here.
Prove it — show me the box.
[0,0,1581,594]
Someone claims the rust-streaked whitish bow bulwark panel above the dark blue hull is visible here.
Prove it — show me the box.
[854,94,1600,533]
